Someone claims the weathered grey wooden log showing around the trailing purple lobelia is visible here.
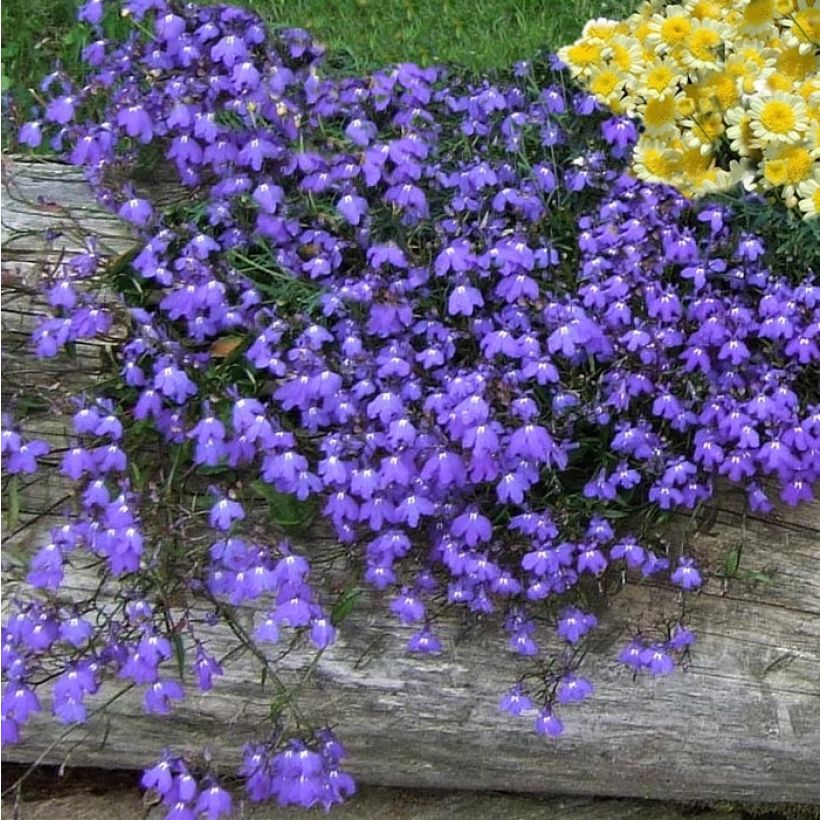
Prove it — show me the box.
[3,160,820,803]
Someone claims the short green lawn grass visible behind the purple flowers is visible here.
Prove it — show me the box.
[2,0,637,109]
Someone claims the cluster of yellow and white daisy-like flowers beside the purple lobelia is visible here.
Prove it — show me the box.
[559,0,820,219]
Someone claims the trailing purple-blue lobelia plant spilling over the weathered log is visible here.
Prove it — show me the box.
[2,0,820,818]
